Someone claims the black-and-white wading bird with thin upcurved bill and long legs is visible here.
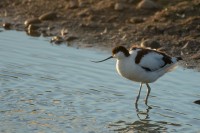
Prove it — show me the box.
[93,46,182,104]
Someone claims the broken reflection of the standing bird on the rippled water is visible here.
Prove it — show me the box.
[111,98,181,133]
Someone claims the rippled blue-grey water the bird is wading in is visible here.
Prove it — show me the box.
[0,31,200,133]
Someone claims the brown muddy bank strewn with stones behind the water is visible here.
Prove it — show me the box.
[0,0,200,70]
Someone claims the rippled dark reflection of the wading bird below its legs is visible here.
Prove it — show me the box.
[109,105,182,133]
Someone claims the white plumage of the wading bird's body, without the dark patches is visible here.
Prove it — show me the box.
[115,49,177,83]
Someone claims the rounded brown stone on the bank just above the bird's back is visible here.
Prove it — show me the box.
[140,39,161,49]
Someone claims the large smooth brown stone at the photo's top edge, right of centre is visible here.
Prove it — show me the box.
[136,0,161,10]
